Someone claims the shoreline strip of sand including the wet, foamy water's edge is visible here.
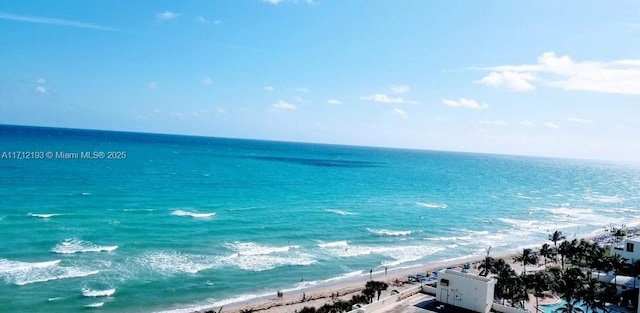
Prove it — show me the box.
[163,225,640,313]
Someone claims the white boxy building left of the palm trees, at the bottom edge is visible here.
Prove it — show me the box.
[436,270,497,313]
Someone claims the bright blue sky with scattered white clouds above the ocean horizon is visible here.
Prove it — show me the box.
[0,0,640,162]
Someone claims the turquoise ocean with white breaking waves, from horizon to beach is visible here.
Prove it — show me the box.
[0,126,640,312]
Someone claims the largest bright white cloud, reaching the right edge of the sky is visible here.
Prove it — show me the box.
[475,52,640,95]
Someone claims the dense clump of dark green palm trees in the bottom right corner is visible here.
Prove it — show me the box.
[478,231,640,313]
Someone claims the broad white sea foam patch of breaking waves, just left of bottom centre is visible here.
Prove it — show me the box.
[222,242,316,272]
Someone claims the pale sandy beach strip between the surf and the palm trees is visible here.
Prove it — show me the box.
[198,227,640,313]
